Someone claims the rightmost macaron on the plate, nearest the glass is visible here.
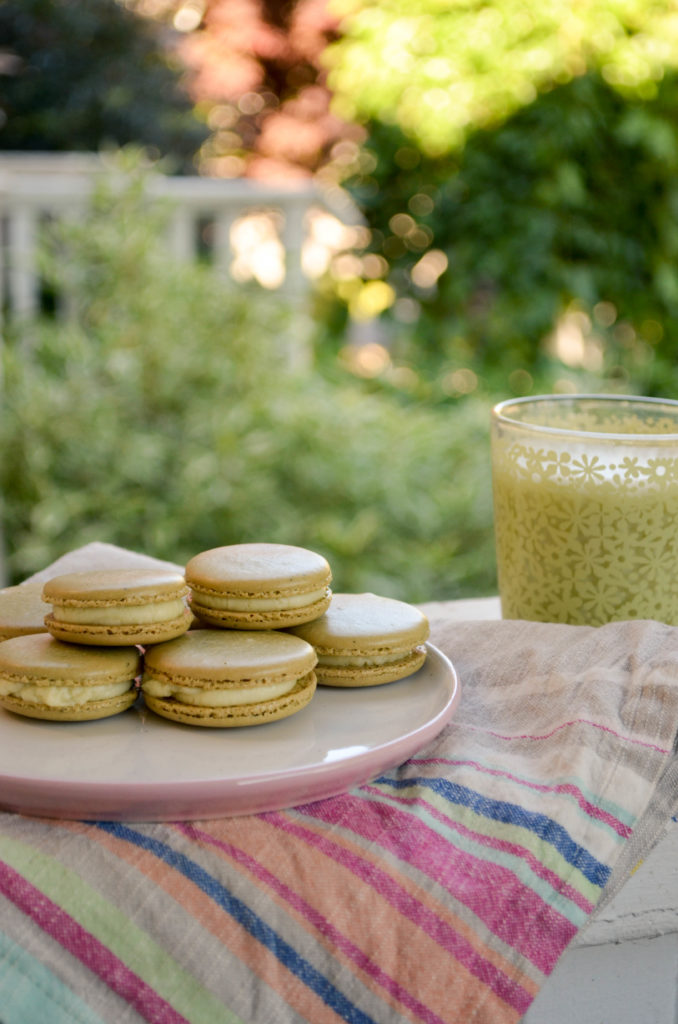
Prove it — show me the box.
[291,594,429,686]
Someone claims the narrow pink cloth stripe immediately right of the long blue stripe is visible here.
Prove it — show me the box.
[175,822,444,1024]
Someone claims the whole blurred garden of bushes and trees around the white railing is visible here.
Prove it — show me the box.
[0,0,678,601]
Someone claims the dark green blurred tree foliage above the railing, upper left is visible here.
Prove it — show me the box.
[0,0,208,169]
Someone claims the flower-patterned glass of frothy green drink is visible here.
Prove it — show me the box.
[492,394,678,626]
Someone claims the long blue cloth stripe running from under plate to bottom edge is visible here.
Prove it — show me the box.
[96,821,375,1024]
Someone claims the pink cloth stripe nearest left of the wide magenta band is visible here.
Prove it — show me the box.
[261,797,534,1014]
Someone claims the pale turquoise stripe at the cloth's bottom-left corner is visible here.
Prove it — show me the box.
[0,932,103,1024]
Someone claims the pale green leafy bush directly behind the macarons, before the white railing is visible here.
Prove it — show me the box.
[0,167,495,600]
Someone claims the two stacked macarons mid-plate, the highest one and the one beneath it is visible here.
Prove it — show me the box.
[141,544,332,727]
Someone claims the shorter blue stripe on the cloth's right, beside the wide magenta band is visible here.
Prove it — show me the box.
[375,775,610,888]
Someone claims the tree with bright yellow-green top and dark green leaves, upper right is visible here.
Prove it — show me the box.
[319,0,678,397]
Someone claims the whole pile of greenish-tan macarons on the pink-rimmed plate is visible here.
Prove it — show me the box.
[0,544,429,727]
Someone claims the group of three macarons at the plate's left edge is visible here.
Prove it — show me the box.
[0,569,193,722]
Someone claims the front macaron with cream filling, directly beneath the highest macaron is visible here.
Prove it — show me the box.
[141,629,316,728]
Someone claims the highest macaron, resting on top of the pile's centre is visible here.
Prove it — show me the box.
[185,544,332,630]
